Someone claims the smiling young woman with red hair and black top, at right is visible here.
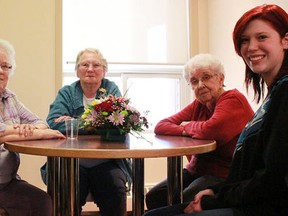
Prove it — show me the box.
[145,4,288,216]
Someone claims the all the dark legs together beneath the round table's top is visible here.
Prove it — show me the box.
[47,156,182,216]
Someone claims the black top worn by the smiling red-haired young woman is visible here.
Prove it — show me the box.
[201,75,288,216]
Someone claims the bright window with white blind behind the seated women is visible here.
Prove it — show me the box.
[62,0,190,130]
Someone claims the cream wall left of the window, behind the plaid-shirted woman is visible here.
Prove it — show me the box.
[0,0,57,189]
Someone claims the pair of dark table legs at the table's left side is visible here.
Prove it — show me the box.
[47,157,80,216]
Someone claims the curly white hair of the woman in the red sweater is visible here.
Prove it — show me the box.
[183,53,225,83]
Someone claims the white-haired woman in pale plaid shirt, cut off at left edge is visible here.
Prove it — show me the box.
[0,39,65,216]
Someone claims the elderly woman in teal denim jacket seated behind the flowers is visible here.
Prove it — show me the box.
[41,48,132,216]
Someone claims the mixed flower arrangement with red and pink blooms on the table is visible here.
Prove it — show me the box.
[80,89,148,141]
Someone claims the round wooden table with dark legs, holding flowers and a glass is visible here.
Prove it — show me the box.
[4,134,216,216]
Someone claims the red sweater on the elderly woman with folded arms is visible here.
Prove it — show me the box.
[154,89,254,178]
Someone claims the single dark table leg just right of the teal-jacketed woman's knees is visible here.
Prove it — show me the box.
[132,158,144,216]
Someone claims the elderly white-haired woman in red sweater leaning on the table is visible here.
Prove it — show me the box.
[146,54,253,210]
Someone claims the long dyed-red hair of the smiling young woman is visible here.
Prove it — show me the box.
[233,4,288,103]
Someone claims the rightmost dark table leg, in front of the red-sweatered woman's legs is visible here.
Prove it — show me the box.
[167,156,183,205]
